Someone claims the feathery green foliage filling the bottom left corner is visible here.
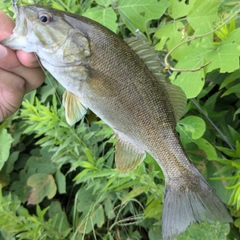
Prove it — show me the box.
[0,190,71,240]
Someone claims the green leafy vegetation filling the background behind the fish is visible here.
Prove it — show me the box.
[0,0,240,240]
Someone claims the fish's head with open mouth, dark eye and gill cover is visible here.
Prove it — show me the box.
[1,5,90,68]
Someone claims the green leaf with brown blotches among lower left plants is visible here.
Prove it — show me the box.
[27,173,57,204]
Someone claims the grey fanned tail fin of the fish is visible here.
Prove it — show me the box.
[162,173,233,240]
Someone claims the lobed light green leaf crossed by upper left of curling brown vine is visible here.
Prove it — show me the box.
[154,22,185,60]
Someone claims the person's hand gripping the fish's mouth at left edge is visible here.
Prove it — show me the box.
[0,11,45,122]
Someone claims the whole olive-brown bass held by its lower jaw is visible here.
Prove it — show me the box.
[1,5,233,240]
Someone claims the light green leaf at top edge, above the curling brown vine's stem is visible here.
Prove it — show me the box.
[187,0,221,35]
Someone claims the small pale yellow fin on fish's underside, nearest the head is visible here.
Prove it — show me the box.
[63,91,87,126]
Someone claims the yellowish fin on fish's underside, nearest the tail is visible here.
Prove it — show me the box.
[115,135,146,173]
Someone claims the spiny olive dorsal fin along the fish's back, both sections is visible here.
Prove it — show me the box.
[125,38,187,122]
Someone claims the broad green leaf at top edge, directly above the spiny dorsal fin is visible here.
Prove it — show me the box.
[118,0,169,32]
